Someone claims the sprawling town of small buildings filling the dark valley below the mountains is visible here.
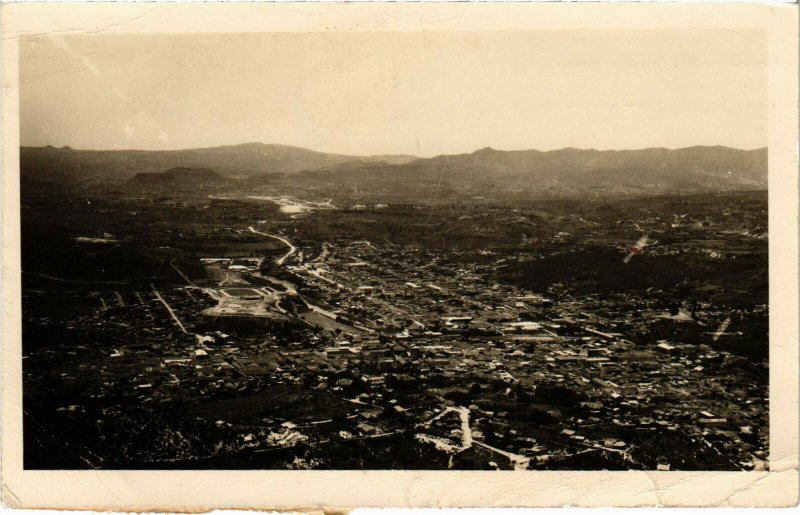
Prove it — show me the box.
[23,190,769,470]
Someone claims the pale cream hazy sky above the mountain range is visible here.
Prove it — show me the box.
[20,30,767,156]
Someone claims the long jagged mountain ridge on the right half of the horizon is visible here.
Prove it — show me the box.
[290,147,767,198]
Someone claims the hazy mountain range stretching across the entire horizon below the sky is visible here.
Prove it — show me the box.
[20,143,767,195]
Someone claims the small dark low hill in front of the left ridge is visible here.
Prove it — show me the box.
[121,167,236,194]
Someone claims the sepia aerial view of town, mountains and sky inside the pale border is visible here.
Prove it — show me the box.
[4,0,797,510]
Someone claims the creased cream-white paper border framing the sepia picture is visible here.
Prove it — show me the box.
[0,3,798,510]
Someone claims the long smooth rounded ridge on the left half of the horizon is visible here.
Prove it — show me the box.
[20,143,417,184]
